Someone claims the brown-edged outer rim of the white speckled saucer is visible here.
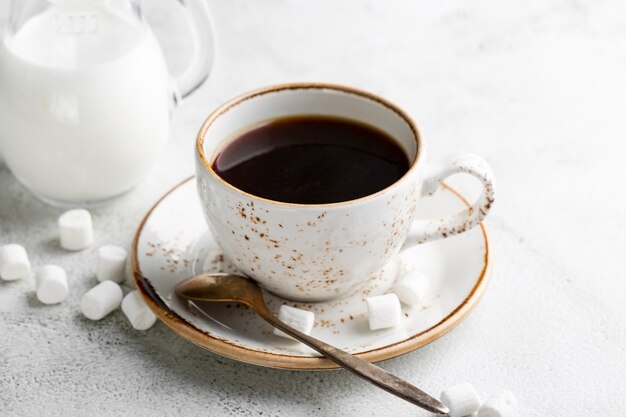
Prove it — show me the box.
[130,176,493,371]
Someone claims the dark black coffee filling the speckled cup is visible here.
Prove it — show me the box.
[213,116,409,204]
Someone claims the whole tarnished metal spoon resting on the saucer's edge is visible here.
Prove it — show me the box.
[176,274,449,414]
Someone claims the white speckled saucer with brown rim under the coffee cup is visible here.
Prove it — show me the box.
[131,178,491,369]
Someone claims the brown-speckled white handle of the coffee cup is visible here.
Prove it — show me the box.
[403,153,495,249]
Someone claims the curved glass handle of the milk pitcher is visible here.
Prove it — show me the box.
[174,0,216,104]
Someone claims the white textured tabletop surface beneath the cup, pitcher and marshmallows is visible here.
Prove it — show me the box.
[0,0,626,416]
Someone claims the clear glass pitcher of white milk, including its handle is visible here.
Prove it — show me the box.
[0,0,215,206]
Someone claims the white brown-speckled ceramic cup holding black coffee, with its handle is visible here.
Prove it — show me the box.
[196,84,494,301]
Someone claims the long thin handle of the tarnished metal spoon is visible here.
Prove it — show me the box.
[257,308,449,414]
